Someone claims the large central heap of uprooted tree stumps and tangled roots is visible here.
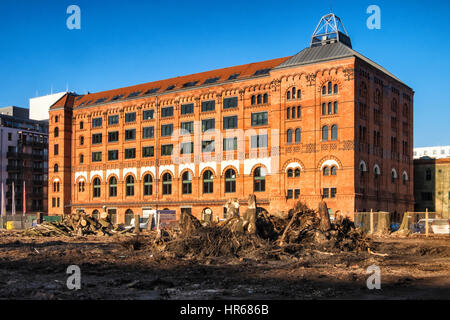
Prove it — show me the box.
[149,195,371,258]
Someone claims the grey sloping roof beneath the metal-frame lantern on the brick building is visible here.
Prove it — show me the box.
[274,42,407,86]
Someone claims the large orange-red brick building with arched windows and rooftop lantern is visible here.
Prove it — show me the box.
[49,14,414,222]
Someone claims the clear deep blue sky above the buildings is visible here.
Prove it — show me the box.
[0,0,450,147]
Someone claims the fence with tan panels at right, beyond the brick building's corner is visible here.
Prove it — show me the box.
[354,211,441,235]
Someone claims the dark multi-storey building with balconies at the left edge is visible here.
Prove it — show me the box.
[0,106,48,214]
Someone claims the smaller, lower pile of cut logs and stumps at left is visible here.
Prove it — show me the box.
[24,210,134,237]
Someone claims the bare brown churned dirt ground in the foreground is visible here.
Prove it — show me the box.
[0,231,450,300]
